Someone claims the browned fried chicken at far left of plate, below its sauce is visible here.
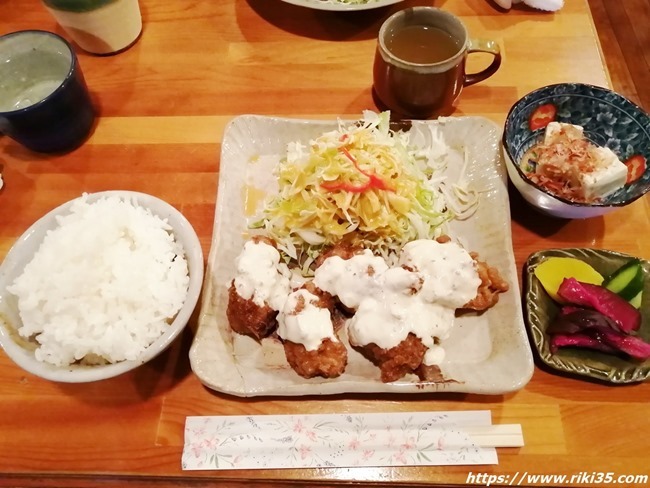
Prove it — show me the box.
[226,280,278,340]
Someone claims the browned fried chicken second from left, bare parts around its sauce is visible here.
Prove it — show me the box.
[282,281,348,378]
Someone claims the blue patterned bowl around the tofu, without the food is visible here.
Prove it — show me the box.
[503,83,650,219]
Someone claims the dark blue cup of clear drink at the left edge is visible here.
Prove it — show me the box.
[0,30,95,153]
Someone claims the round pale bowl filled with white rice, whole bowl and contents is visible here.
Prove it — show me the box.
[0,191,203,382]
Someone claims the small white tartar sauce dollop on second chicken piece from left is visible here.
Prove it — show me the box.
[278,288,338,351]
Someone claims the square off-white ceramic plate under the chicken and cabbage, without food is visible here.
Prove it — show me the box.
[190,115,533,396]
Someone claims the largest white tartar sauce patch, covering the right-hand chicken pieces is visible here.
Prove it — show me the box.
[314,239,481,365]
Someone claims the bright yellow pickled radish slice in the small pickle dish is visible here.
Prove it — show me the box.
[535,256,605,302]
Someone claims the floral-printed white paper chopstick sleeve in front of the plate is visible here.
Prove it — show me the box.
[182,411,498,470]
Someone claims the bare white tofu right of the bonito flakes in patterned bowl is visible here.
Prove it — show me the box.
[580,147,627,199]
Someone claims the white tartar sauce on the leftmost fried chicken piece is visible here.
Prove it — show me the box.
[235,241,291,310]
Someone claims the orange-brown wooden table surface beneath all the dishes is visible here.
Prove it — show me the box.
[0,0,650,487]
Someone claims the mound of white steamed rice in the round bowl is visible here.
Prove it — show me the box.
[8,195,189,366]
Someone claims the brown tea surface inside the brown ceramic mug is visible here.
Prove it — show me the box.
[386,25,462,64]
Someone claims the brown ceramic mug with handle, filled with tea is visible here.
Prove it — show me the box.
[373,7,501,119]
